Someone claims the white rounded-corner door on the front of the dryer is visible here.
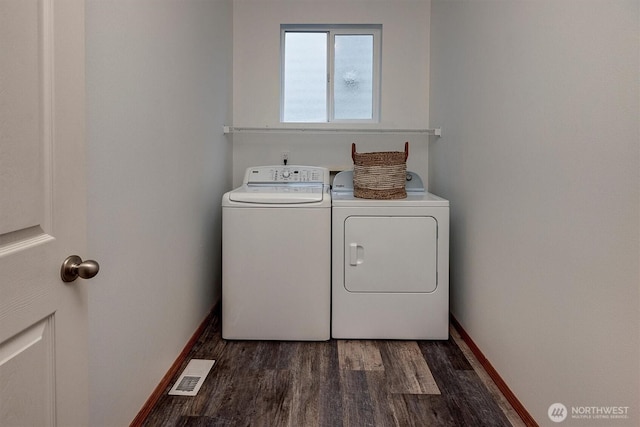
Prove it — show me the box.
[344,216,438,293]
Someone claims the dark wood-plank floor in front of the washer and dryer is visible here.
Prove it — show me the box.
[143,310,521,427]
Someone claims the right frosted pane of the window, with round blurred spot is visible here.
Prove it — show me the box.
[333,35,373,120]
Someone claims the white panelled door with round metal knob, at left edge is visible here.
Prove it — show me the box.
[0,0,89,427]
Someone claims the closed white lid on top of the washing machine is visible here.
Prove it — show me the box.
[229,184,327,204]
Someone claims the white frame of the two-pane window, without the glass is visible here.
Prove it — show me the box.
[280,24,382,125]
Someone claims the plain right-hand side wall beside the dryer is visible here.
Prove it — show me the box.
[429,0,640,426]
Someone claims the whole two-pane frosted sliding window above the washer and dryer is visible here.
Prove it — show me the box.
[280,24,382,123]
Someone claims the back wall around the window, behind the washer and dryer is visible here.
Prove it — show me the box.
[229,0,430,185]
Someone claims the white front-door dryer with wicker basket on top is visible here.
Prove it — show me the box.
[331,171,449,339]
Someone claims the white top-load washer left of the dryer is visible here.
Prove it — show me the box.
[222,166,331,341]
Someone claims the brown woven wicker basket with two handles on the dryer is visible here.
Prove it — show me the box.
[351,142,409,200]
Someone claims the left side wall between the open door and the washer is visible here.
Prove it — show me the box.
[86,0,232,426]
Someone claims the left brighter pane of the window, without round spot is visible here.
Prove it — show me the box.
[283,32,328,122]
